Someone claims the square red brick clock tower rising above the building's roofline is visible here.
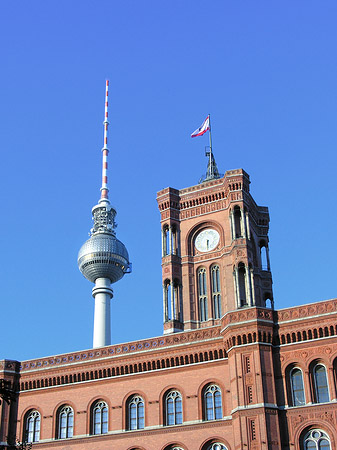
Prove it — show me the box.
[157,158,273,333]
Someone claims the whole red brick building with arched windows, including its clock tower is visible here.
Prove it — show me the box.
[0,169,337,450]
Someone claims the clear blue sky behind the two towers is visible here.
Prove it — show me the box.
[0,0,337,360]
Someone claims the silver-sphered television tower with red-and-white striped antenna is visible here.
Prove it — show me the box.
[77,80,131,348]
